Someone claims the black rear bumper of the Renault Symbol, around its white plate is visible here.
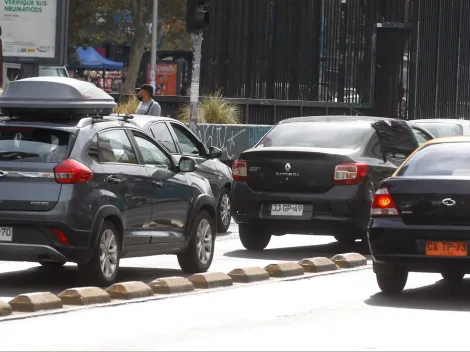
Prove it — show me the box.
[230,182,372,236]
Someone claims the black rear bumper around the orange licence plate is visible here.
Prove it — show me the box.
[367,218,470,273]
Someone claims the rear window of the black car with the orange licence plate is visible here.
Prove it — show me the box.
[397,143,470,176]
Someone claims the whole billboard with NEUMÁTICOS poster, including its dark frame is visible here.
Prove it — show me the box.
[0,0,69,66]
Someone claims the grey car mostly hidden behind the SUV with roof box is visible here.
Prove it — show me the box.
[131,115,233,233]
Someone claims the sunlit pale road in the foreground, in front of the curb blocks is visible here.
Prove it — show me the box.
[0,269,470,351]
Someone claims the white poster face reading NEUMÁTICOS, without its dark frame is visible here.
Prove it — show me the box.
[0,0,58,59]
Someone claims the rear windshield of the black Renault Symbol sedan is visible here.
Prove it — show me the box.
[258,122,371,149]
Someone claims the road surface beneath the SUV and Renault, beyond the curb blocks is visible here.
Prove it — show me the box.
[0,224,367,302]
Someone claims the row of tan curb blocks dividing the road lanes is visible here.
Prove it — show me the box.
[0,253,370,321]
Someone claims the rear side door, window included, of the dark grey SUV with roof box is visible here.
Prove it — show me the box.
[98,129,152,249]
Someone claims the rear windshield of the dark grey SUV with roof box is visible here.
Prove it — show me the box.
[0,126,70,163]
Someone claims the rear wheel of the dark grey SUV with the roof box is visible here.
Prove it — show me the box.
[79,220,122,286]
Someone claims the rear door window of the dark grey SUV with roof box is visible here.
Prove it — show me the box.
[98,130,137,164]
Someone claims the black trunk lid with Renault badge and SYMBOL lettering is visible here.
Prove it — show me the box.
[240,147,355,193]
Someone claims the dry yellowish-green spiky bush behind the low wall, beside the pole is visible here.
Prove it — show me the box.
[178,91,240,124]
